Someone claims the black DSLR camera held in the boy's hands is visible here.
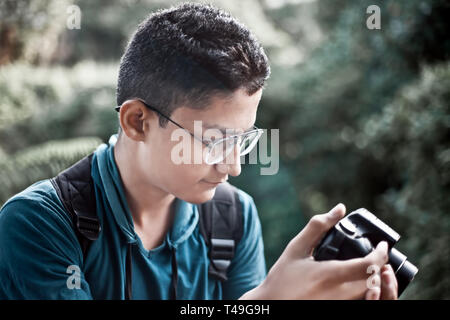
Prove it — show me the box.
[313,208,418,296]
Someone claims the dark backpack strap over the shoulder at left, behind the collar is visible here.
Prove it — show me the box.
[50,153,101,257]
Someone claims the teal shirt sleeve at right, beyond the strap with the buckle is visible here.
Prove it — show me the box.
[223,190,267,300]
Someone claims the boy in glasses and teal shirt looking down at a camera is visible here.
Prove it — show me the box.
[0,3,397,299]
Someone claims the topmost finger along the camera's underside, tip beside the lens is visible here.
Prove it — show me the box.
[323,241,388,281]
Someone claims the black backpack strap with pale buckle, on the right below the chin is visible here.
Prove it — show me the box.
[198,182,243,281]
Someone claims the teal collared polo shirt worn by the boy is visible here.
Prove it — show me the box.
[0,135,266,299]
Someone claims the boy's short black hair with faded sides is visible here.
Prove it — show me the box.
[117,3,270,126]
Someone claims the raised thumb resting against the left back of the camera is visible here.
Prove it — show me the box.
[289,203,346,257]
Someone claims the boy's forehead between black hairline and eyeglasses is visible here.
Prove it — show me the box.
[172,89,262,132]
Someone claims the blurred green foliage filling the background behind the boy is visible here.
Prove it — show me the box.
[0,0,450,299]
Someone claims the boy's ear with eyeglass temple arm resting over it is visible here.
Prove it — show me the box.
[119,100,158,141]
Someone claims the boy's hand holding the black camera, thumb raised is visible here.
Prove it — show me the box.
[242,204,397,299]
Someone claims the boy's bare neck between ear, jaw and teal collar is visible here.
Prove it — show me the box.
[114,139,175,226]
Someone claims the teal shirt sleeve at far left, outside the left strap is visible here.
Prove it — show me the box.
[0,198,92,300]
